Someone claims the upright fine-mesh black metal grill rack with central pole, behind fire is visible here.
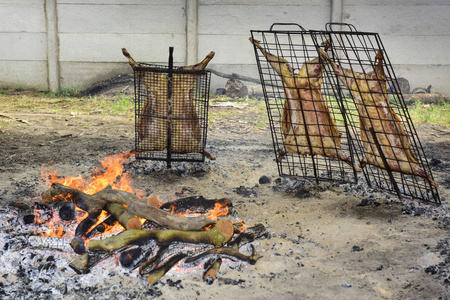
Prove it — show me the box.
[133,47,211,168]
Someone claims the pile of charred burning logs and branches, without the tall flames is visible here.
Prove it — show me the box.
[38,177,265,285]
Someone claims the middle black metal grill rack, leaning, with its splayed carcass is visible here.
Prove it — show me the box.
[251,23,357,183]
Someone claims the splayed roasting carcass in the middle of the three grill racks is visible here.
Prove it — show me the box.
[250,38,353,167]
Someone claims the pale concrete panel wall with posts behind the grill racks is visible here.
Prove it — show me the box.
[0,0,450,93]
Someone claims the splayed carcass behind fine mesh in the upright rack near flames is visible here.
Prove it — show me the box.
[122,48,215,160]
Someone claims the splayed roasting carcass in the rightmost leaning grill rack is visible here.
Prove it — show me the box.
[319,49,438,186]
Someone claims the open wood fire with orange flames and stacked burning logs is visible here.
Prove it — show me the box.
[6,151,266,285]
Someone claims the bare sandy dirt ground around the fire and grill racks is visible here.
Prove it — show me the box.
[0,98,450,299]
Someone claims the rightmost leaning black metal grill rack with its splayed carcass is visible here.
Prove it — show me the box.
[312,23,441,204]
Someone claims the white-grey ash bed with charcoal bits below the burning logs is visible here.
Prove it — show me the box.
[0,209,258,300]
